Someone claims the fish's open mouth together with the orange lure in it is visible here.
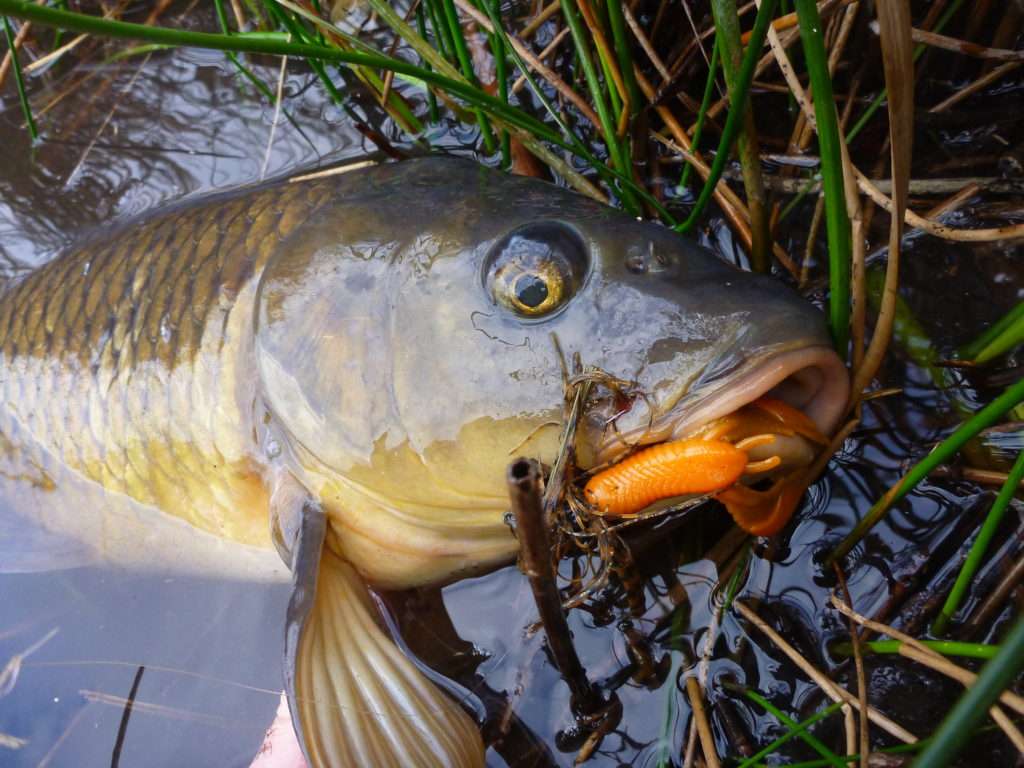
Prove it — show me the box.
[585,345,849,536]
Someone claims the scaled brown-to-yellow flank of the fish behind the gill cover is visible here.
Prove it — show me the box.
[0,182,330,545]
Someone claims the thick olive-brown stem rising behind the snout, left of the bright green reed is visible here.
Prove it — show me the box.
[712,0,771,272]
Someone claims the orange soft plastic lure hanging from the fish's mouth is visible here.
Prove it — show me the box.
[584,397,827,536]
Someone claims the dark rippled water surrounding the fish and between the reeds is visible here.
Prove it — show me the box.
[0,7,1024,768]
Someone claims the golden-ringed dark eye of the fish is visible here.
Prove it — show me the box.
[485,222,588,318]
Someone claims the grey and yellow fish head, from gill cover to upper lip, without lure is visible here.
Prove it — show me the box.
[255,158,847,587]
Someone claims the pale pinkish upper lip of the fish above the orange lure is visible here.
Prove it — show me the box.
[594,344,850,466]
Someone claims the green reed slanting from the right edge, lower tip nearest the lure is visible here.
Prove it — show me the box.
[827,378,1024,567]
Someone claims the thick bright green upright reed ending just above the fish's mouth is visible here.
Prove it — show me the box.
[795,0,852,357]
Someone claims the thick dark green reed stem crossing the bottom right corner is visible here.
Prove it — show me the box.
[912,616,1024,768]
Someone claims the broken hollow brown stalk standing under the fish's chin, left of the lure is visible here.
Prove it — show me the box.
[507,459,606,717]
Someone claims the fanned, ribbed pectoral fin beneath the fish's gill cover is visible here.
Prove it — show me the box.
[286,505,484,768]
